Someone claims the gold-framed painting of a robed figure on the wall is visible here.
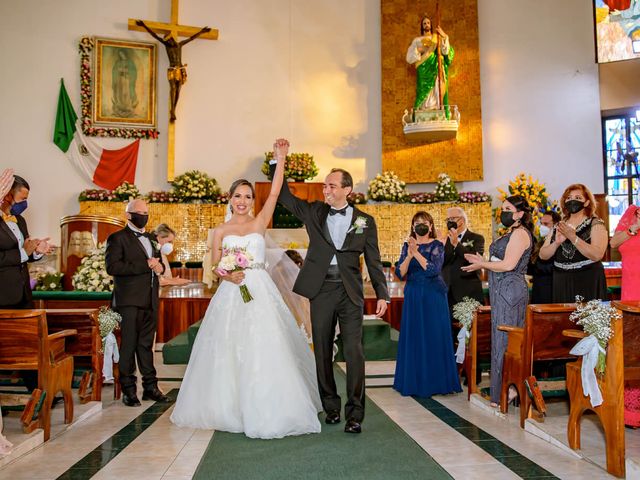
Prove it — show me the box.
[91,37,157,130]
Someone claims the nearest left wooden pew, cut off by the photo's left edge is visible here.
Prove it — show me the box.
[0,310,76,441]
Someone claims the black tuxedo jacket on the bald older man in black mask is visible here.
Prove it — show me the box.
[105,227,162,310]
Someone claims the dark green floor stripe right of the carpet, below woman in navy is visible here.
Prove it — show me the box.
[414,397,558,479]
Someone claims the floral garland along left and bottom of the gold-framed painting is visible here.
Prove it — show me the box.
[78,37,158,139]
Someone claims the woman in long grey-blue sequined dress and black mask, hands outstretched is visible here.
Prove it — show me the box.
[462,195,533,411]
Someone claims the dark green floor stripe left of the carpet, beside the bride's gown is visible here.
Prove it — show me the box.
[57,389,178,480]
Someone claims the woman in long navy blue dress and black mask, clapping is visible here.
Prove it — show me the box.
[393,212,462,397]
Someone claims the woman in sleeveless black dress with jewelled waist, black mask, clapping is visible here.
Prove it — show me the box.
[540,183,609,303]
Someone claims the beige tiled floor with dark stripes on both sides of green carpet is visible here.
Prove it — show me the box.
[0,355,635,480]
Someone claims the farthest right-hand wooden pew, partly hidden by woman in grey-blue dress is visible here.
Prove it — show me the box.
[462,306,491,400]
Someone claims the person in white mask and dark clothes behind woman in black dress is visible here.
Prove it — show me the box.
[527,210,560,303]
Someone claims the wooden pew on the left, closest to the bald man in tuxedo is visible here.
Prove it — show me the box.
[45,308,103,403]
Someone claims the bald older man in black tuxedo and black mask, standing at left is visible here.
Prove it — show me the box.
[105,199,170,407]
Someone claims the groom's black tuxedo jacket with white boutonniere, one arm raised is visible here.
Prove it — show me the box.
[278,180,390,306]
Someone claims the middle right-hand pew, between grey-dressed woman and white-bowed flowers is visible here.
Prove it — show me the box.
[498,303,576,428]
